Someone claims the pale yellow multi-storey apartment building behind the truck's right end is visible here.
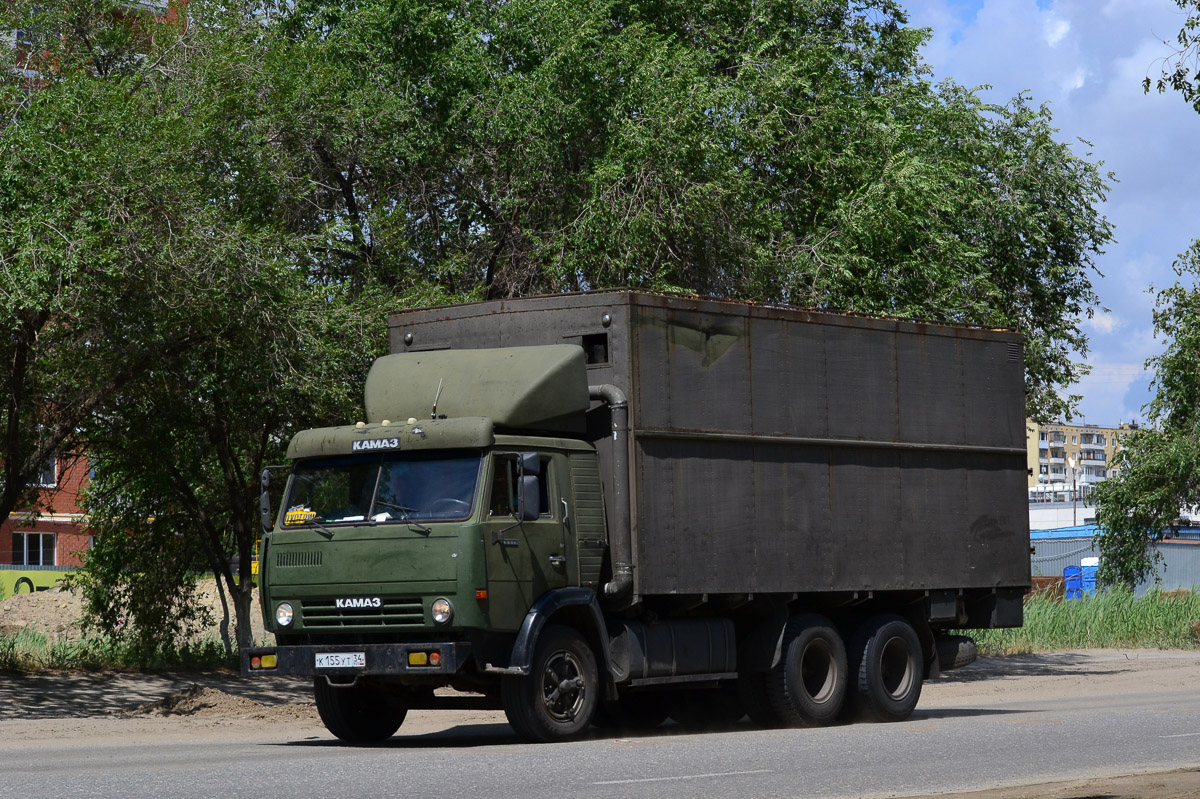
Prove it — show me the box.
[1025,420,1138,494]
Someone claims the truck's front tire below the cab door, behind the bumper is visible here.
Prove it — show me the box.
[500,625,600,743]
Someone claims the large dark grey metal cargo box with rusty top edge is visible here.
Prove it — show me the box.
[390,292,1030,595]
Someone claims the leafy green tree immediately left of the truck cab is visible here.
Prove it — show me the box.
[54,1,385,654]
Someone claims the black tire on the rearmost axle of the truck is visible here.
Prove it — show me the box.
[851,614,924,721]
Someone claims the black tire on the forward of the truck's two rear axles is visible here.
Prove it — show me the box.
[767,613,850,727]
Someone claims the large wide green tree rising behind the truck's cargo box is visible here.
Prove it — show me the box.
[253,0,1111,419]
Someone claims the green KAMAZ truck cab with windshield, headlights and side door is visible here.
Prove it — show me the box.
[244,346,606,740]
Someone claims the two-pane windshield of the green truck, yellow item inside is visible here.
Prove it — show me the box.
[283,452,481,527]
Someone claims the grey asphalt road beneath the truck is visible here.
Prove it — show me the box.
[0,656,1200,799]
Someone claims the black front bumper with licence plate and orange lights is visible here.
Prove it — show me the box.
[241,641,470,677]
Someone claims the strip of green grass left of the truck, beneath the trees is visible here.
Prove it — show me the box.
[0,630,236,672]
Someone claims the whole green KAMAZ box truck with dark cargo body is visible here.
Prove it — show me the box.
[242,292,1030,741]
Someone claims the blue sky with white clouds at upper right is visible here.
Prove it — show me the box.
[901,0,1200,427]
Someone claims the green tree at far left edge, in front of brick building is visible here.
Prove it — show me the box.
[0,0,198,532]
